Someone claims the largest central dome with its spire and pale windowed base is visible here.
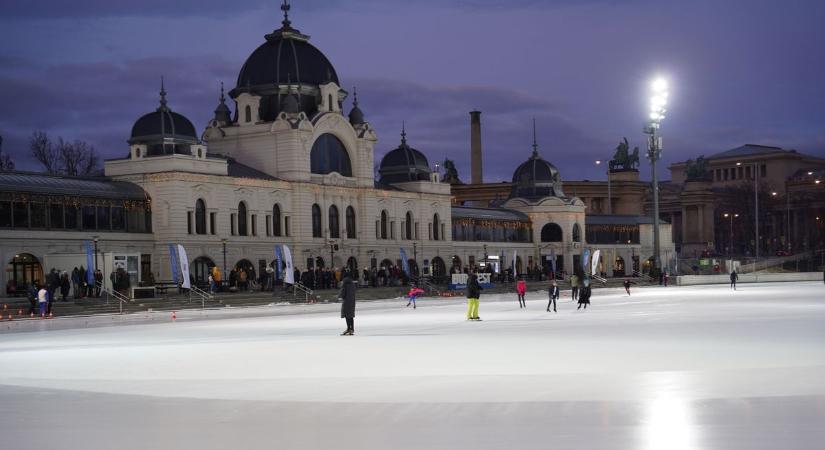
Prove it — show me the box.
[229,2,346,125]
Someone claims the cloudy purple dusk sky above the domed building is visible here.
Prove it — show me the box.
[0,0,825,181]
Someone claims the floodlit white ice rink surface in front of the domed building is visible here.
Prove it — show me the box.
[0,282,825,450]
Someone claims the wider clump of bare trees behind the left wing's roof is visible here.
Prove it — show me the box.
[31,131,100,176]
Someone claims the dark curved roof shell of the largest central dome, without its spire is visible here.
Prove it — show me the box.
[237,29,340,89]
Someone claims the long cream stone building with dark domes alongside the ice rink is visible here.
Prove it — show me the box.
[0,7,669,296]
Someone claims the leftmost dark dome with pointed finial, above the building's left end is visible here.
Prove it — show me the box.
[128,78,206,159]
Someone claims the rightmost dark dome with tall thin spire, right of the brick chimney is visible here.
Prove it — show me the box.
[510,120,565,200]
